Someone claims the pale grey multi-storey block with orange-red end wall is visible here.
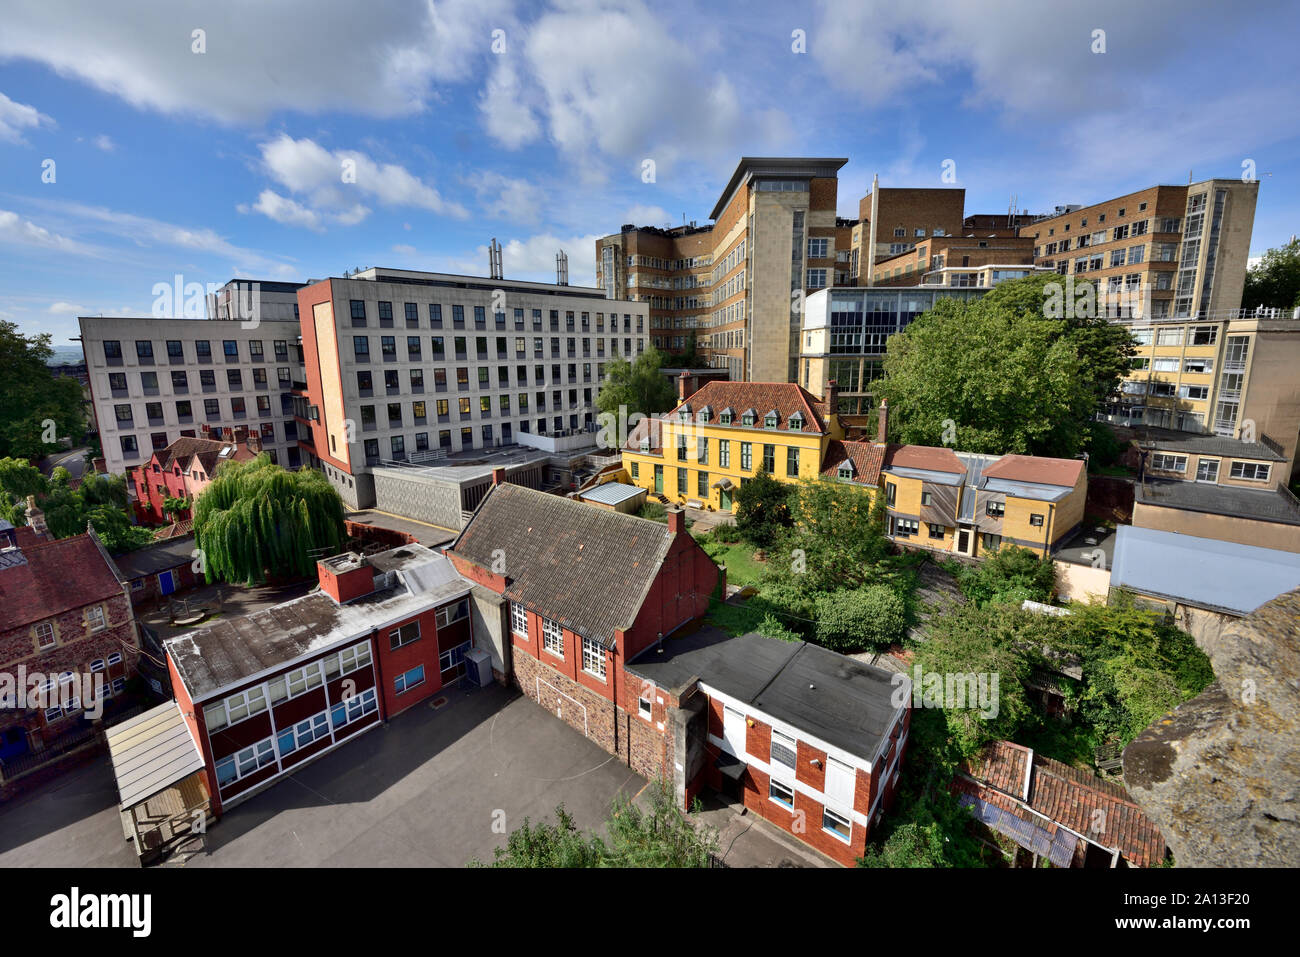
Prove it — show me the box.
[295,268,647,508]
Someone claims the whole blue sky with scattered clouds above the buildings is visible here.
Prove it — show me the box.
[0,0,1300,346]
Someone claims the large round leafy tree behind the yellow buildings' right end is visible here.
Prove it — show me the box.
[875,276,1134,456]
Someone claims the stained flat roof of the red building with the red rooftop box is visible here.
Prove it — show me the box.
[164,545,472,702]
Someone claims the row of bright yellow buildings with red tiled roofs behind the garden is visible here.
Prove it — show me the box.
[623,381,1088,558]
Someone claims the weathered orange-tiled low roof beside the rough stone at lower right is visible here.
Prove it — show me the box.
[957,741,1165,867]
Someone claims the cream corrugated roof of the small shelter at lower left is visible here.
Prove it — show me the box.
[107,701,203,810]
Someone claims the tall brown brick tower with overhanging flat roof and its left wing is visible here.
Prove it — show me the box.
[595,156,847,381]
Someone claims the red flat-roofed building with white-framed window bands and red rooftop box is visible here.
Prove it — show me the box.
[165,545,473,815]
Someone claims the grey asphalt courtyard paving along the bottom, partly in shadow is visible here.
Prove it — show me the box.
[0,687,827,867]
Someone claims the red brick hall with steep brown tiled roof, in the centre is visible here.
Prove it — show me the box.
[447,484,725,778]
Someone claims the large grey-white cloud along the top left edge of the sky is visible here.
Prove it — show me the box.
[0,0,512,124]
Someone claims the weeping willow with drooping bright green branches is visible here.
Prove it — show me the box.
[194,452,343,585]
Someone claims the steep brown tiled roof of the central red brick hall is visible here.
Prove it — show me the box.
[449,484,675,648]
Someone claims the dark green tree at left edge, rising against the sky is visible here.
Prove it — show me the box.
[0,321,86,459]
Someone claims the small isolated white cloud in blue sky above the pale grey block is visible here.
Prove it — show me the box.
[239,134,468,230]
